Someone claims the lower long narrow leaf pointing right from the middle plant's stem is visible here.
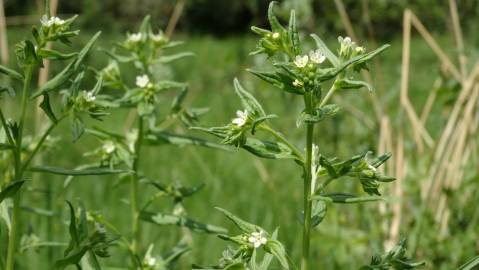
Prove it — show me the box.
[140,211,227,233]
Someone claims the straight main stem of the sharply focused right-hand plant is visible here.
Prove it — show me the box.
[301,92,314,270]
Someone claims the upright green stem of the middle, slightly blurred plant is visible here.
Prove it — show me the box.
[130,116,144,263]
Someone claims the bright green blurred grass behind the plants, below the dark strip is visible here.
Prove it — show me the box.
[0,21,479,269]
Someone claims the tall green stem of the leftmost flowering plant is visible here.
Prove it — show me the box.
[5,66,33,270]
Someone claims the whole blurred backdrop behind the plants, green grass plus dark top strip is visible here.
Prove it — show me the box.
[0,0,479,269]
